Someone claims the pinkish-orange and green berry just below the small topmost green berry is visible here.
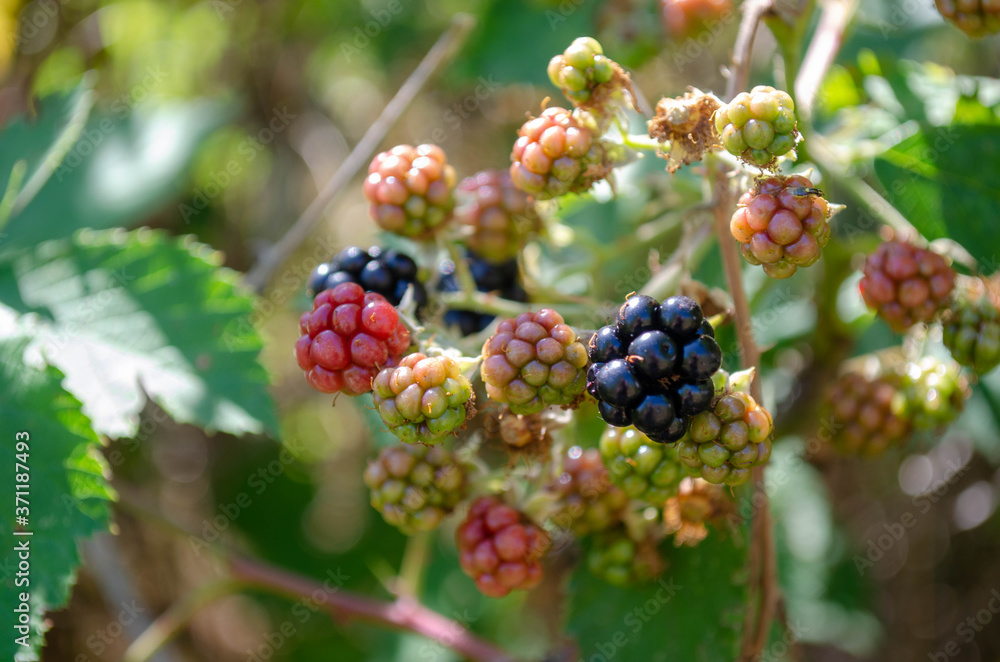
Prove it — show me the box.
[510,106,611,200]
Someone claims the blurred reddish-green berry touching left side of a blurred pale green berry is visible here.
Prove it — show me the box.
[824,373,913,455]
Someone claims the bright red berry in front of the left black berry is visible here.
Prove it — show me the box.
[295,283,410,395]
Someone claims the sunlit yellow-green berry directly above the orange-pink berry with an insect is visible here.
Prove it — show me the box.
[715,85,799,169]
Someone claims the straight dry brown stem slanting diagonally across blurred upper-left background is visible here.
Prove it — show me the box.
[245,14,475,292]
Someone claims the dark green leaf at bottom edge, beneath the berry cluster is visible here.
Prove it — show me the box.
[569,530,746,662]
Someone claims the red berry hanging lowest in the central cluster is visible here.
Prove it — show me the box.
[455,497,550,598]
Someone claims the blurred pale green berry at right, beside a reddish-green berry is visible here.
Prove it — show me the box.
[902,356,971,430]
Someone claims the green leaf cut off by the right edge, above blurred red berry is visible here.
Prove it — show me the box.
[875,126,1000,273]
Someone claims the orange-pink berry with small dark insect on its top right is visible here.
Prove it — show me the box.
[729,175,830,278]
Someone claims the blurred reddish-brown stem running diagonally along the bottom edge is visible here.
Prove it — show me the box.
[229,557,515,662]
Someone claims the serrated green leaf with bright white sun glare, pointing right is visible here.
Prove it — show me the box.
[0,230,277,437]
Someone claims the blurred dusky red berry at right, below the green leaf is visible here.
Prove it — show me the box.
[860,241,955,332]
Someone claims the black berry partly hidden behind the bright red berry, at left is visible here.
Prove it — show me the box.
[308,246,427,307]
